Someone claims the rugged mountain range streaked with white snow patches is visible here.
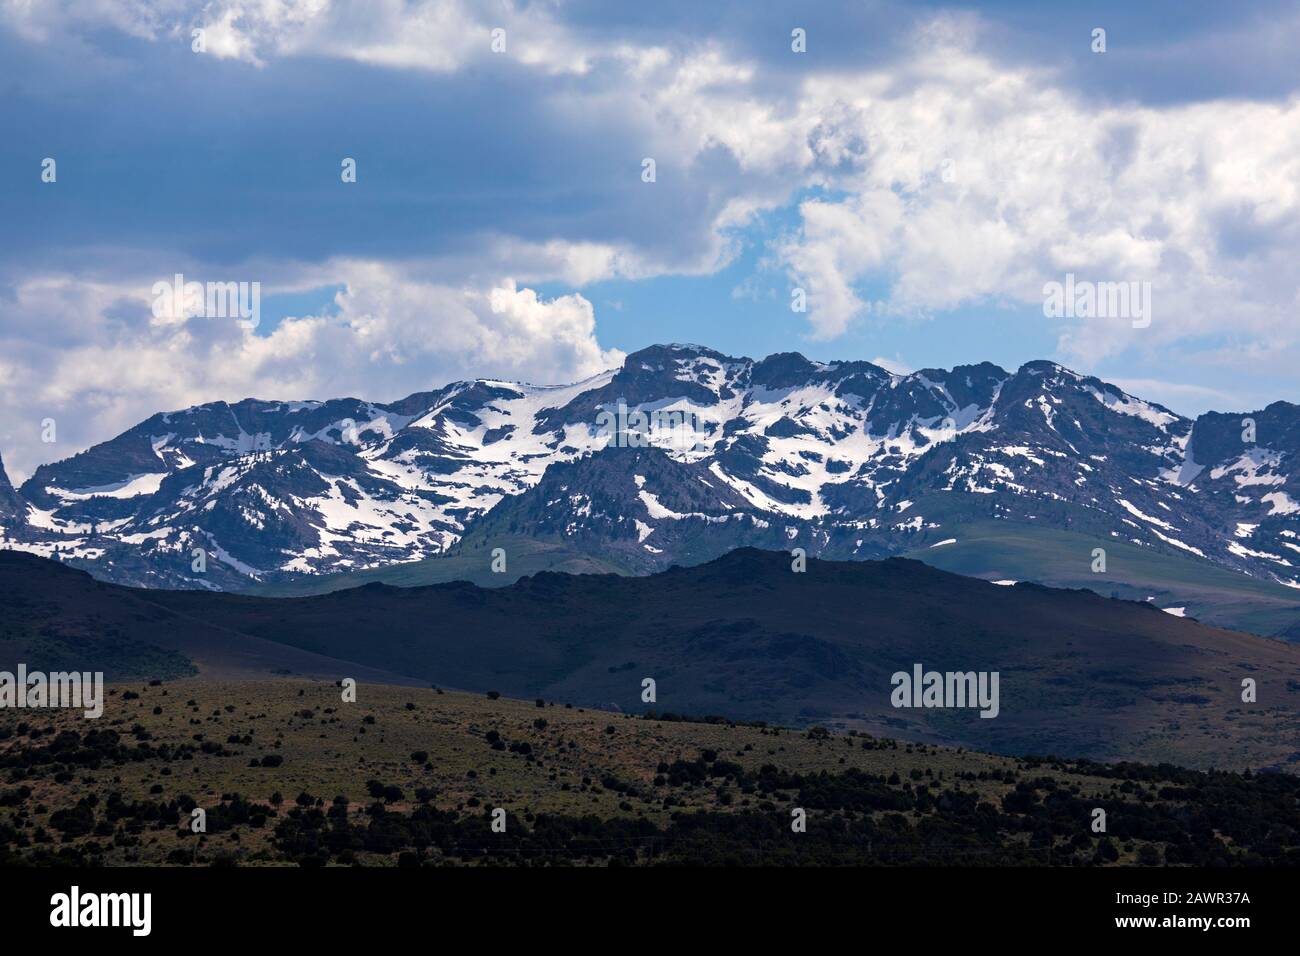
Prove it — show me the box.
[0,345,1300,588]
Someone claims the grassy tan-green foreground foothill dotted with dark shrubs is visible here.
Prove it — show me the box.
[0,679,1300,866]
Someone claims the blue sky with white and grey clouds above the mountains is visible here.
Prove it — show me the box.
[0,0,1300,476]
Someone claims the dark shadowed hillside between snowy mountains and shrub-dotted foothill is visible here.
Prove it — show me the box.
[0,550,1300,766]
